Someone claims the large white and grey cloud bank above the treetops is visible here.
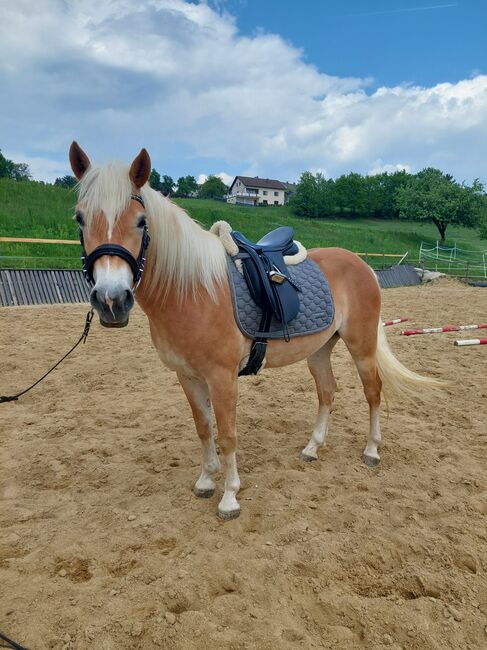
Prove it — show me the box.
[0,0,487,180]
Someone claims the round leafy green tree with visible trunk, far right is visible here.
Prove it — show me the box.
[396,167,483,244]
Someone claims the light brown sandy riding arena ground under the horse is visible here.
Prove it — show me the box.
[0,281,487,650]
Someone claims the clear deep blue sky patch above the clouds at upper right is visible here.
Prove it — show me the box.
[231,0,487,86]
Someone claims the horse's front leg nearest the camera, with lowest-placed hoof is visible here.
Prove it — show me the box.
[208,373,240,519]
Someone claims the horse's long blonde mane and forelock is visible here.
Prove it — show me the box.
[78,163,227,300]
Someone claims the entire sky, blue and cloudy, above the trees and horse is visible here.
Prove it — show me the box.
[0,0,487,183]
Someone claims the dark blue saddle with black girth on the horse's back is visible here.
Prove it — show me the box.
[231,226,301,375]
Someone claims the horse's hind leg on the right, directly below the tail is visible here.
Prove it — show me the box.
[345,340,382,467]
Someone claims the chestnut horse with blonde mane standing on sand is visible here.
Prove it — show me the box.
[69,142,439,519]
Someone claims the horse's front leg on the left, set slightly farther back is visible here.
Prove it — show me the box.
[178,373,220,498]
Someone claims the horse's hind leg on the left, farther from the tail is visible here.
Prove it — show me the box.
[301,334,339,461]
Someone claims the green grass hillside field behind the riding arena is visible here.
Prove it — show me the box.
[0,180,487,268]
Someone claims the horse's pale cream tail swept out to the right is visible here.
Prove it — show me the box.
[376,320,446,399]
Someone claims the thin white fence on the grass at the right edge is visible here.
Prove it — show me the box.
[419,242,487,279]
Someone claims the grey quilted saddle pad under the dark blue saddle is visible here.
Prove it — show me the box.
[227,255,335,339]
